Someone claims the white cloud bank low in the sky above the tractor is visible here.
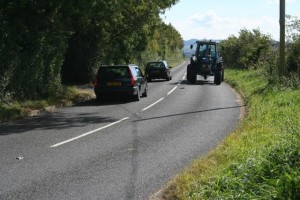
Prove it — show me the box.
[173,10,279,39]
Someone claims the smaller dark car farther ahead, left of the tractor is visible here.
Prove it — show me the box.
[145,61,172,82]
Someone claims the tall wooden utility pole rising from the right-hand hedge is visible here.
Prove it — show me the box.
[278,0,285,77]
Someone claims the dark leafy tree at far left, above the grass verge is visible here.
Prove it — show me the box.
[0,0,70,99]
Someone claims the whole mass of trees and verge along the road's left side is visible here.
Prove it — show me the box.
[0,0,183,122]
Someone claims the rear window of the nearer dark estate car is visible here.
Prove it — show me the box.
[99,67,130,80]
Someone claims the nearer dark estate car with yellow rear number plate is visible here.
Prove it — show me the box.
[93,64,148,102]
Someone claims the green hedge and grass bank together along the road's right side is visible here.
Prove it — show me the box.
[162,18,300,200]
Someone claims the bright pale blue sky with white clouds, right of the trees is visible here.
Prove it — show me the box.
[161,0,300,40]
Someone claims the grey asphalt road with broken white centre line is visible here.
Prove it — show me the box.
[0,63,240,200]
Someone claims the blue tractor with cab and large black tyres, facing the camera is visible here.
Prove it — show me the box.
[187,40,224,85]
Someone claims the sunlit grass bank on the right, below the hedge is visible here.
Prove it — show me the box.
[163,69,300,200]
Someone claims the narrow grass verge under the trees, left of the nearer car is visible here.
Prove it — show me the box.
[0,86,92,123]
